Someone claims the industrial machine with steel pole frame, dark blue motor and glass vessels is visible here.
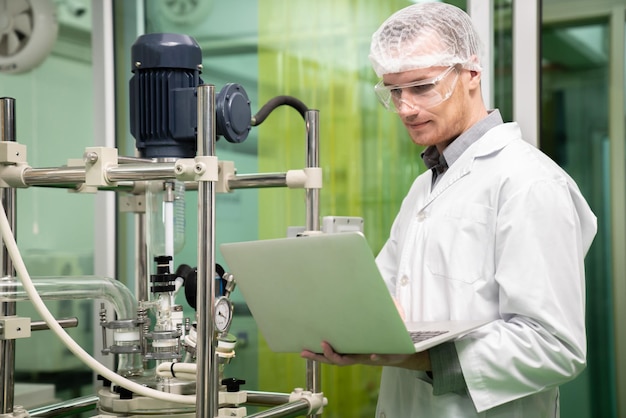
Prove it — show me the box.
[0,34,326,418]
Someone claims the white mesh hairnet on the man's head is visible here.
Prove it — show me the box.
[369,3,482,77]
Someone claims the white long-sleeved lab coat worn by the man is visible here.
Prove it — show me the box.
[377,123,597,418]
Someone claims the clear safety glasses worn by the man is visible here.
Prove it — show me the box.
[374,65,459,112]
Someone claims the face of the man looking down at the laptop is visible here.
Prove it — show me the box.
[383,67,472,152]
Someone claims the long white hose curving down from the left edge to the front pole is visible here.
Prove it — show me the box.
[0,201,196,404]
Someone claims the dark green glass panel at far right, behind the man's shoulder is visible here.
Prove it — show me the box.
[541,21,616,417]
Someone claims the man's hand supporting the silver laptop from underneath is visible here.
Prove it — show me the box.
[300,342,431,371]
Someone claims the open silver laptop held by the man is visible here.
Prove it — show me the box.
[220,232,488,354]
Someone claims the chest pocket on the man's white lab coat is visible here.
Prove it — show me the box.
[425,202,494,284]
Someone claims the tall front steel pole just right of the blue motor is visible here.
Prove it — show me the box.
[196,85,219,418]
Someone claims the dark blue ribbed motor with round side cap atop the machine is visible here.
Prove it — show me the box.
[129,33,251,158]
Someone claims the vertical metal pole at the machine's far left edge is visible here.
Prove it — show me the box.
[0,97,17,414]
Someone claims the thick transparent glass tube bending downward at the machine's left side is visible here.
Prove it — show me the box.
[0,276,137,319]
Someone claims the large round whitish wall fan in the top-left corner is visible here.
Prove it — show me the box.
[0,0,59,73]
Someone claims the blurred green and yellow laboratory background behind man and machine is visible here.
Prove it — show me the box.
[0,0,626,418]
